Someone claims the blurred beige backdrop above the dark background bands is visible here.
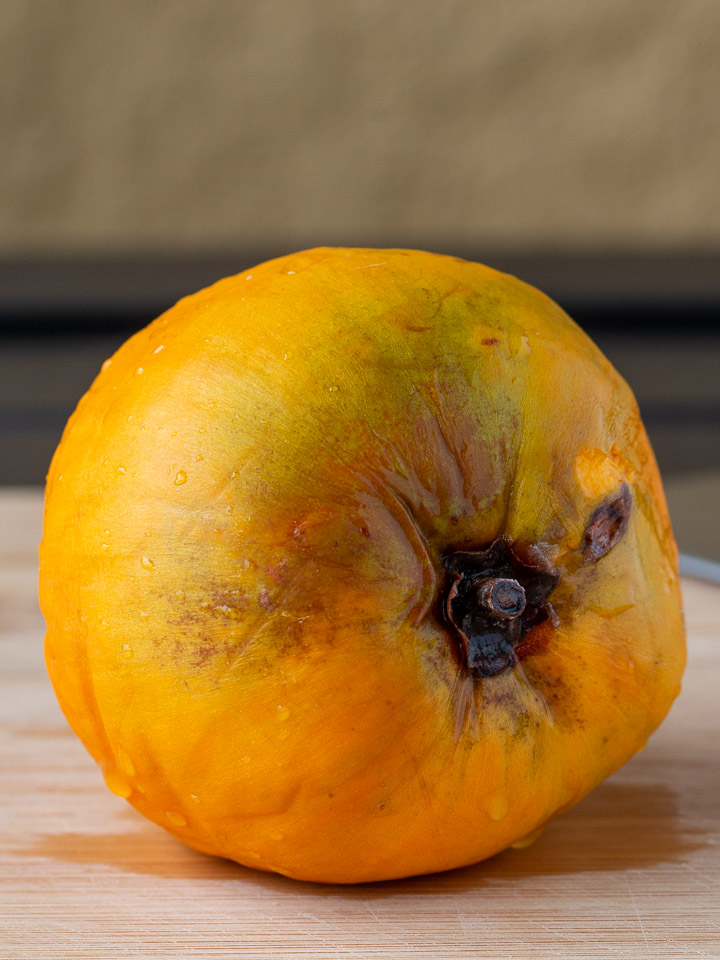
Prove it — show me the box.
[0,0,720,255]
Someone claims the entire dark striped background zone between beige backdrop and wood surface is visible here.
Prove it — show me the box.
[0,249,720,484]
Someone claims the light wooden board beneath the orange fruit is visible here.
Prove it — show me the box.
[0,490,720,960]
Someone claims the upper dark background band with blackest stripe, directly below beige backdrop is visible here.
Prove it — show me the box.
[0,249,720,336]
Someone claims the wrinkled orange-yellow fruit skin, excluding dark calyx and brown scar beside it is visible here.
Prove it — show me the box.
[41,249,685,883]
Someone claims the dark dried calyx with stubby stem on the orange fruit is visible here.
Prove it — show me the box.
[442,539,559,678]
